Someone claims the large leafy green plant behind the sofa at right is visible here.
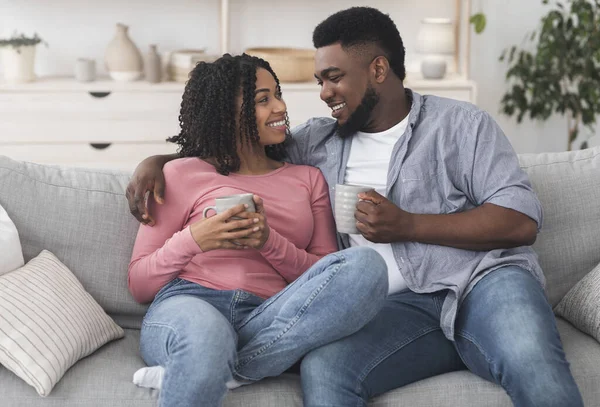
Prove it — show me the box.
[500,0,600,150]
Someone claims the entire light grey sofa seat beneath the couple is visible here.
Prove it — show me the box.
[0,319,600,407]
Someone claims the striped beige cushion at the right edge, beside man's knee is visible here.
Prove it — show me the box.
[554,264,600,342]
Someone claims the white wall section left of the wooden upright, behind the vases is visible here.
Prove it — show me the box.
[0,0,219,75]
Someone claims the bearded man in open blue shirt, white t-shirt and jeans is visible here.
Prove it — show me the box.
[128,7,583,407]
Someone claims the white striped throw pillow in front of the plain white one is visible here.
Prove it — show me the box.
[0,250,124,396]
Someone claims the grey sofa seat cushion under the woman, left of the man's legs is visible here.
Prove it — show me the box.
[0,329,302,407]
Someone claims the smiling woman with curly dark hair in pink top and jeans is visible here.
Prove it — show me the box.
[129,55,387,407]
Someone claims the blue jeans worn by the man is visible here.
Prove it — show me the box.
[301,267,583,407]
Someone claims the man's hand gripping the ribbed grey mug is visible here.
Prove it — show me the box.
[354,191,414,243]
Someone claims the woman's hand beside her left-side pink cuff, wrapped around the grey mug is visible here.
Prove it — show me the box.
[190,204,260,252]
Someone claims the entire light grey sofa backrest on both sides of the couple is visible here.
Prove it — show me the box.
[0,148,600,328]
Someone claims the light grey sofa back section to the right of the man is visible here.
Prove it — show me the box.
[519,147,600,306]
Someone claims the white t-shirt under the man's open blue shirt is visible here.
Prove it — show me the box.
[344,116,408,294]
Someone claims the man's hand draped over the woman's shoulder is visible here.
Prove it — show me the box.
[125,155,175,226]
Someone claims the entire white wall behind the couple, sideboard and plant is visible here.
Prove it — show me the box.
[0,0,600,152]
